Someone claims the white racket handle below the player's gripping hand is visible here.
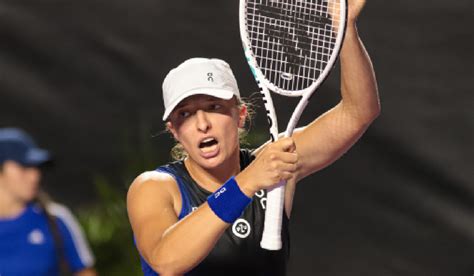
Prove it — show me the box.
[260,181,286,250]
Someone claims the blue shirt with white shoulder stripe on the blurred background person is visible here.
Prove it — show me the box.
[0,203,94,276]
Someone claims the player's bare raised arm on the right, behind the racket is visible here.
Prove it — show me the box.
[288,0,380,179]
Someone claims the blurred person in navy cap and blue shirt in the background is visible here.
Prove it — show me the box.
[0,128,96,276]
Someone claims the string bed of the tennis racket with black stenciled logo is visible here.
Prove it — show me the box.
[246,0,340,91]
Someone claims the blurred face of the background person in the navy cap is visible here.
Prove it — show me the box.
[0,161,41,203]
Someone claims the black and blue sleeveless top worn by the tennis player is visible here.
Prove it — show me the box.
[141,149,290,276]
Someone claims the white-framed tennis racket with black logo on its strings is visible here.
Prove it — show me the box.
[239,0,347,250]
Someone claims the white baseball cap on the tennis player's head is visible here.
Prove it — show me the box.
[163,58,240,121]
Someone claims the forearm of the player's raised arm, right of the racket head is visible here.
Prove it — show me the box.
[340,22,380,124]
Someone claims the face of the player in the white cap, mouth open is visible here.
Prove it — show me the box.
[168,95,246,169]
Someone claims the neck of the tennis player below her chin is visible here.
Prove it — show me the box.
[184,150,240,192]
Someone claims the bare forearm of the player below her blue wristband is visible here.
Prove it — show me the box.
[150,203,229,275]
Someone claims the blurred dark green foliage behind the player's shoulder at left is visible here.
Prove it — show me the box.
[77,123,170,276]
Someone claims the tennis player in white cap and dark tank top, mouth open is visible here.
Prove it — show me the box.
[127,0,380,275]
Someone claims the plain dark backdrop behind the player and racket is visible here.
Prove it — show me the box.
[0,0,474,276]
